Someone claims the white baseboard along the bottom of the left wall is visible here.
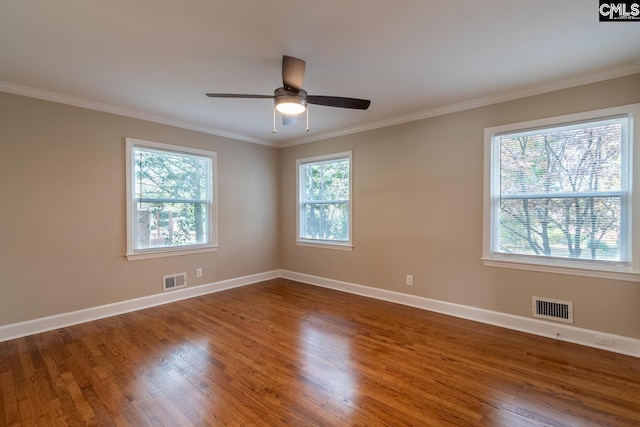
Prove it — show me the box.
[0,270,281,342]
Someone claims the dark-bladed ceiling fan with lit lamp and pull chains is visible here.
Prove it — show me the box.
[205,55,371,133]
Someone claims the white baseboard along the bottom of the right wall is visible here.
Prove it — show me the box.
[281,270,640,357]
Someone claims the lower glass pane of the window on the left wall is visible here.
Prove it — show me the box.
[135,203,208,249]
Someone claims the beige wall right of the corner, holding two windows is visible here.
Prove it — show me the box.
[280,74,640,338]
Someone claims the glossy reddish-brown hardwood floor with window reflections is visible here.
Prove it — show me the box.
[0,279,640,427]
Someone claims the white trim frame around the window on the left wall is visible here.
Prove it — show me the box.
[125,138,218,261]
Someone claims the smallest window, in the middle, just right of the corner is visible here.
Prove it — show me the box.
[297,152,353,250]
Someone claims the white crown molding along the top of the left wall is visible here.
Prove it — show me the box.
[0,81,276,147]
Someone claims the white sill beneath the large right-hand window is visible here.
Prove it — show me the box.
[482,257,640,282]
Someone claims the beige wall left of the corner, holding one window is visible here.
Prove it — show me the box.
[0,93,279,325]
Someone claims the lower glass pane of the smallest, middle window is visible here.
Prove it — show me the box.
[300,203,349,241]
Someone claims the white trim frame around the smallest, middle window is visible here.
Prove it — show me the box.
[296,151,353,251]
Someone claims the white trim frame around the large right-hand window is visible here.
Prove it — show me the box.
[482,104,640,282]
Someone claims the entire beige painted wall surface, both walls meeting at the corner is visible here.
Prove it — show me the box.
[0,75,640,338]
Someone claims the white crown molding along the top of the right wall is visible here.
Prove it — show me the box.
[277,60,640,148]
